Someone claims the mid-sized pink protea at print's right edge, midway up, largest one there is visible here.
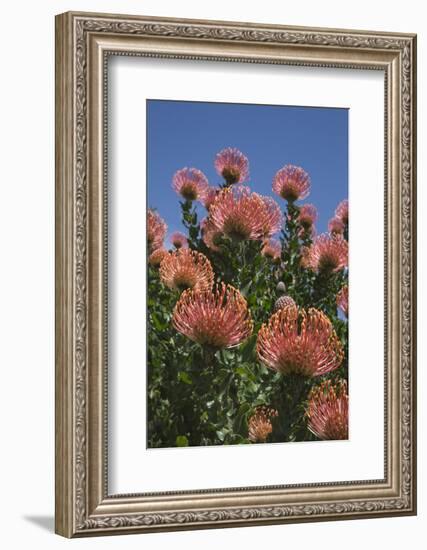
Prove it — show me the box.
[301,233,348,273]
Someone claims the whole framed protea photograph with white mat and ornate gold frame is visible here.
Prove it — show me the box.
[56,12,416,537]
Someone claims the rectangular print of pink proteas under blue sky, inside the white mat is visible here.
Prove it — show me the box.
[147,100,349,448]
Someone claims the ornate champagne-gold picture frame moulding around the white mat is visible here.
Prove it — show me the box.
[55,13,416,537]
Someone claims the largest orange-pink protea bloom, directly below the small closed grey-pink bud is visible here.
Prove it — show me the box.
[256,305,344,377]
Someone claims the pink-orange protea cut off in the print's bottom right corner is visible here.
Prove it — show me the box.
[306,380,348,440]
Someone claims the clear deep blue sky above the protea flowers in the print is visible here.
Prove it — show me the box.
[147,100,348,244]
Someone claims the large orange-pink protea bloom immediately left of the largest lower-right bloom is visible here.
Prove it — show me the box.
[172,283,253,350]
